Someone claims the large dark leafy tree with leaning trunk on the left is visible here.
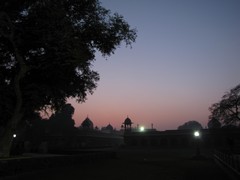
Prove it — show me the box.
[0,0,136,156]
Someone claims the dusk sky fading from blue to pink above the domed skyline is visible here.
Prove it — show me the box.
[70,0,240,131]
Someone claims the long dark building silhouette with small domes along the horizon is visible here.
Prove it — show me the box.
[6,116,240,153]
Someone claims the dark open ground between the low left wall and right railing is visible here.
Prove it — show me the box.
[1,149,229,180]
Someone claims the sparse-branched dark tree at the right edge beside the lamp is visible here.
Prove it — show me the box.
[209,84,240,125]
